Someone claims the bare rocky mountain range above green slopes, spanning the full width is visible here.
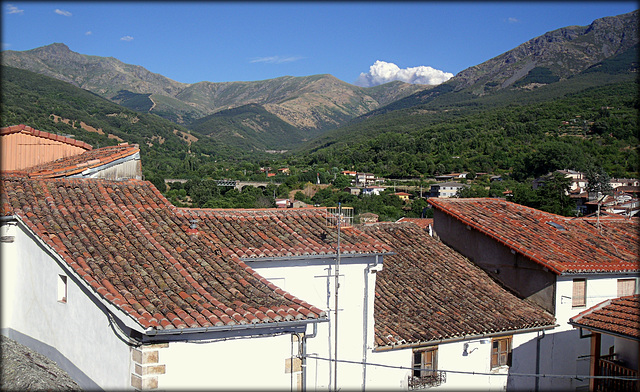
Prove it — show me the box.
[2,11,638,151]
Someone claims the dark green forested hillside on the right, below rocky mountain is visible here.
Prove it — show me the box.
[299,76,638,180]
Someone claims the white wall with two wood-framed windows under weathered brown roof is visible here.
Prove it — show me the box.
[367,332,544,391]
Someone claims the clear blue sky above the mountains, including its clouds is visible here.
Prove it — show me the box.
[2,1,638,85]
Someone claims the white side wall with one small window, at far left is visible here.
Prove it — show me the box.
[1,223,130,390]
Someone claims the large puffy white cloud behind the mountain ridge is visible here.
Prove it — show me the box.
[355,60,453,87]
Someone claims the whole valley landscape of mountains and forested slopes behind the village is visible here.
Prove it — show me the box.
[2,11,640,220]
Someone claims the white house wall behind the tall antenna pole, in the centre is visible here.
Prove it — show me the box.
[248,256,382,390]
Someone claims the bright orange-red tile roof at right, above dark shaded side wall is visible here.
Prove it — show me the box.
[429,198,640,274]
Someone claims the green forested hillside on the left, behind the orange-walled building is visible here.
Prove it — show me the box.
[1,67,258,183]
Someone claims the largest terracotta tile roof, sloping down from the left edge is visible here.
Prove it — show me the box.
[0,173,326,329]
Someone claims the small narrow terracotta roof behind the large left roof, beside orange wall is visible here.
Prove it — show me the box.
[24,143,140,178]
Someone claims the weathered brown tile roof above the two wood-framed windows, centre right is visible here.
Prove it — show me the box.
[363,223,555,347]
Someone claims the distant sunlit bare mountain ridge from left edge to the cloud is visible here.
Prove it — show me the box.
[2,43,429,131]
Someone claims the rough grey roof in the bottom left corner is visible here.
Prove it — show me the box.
[0,336,82,391]
